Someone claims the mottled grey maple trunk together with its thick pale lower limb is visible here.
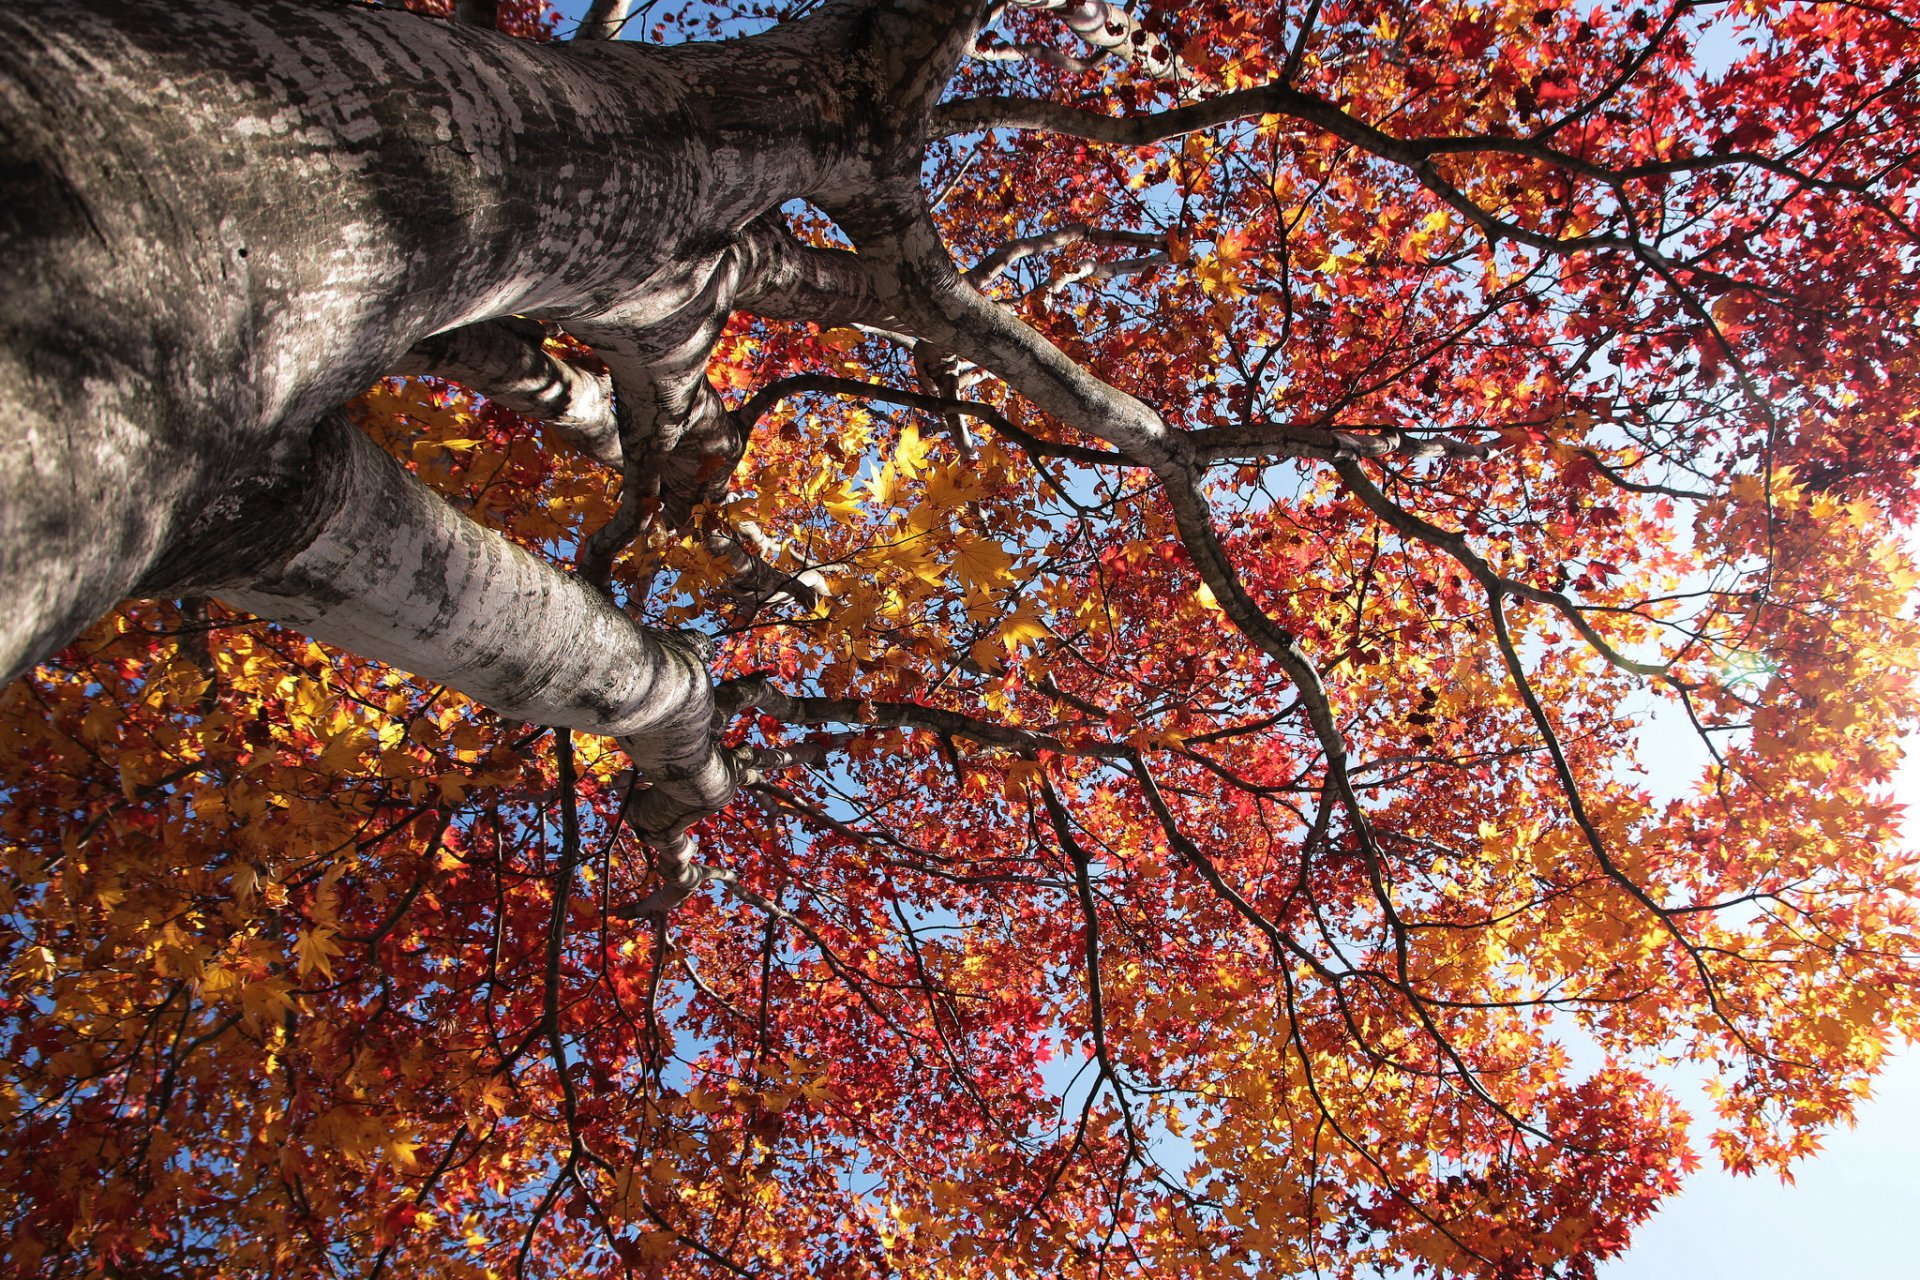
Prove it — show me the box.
[0,0,979,852]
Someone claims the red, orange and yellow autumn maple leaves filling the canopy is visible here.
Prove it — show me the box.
[0,0,1920,1278]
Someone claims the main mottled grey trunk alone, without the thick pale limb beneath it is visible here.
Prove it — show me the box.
[0,4,837,676]
